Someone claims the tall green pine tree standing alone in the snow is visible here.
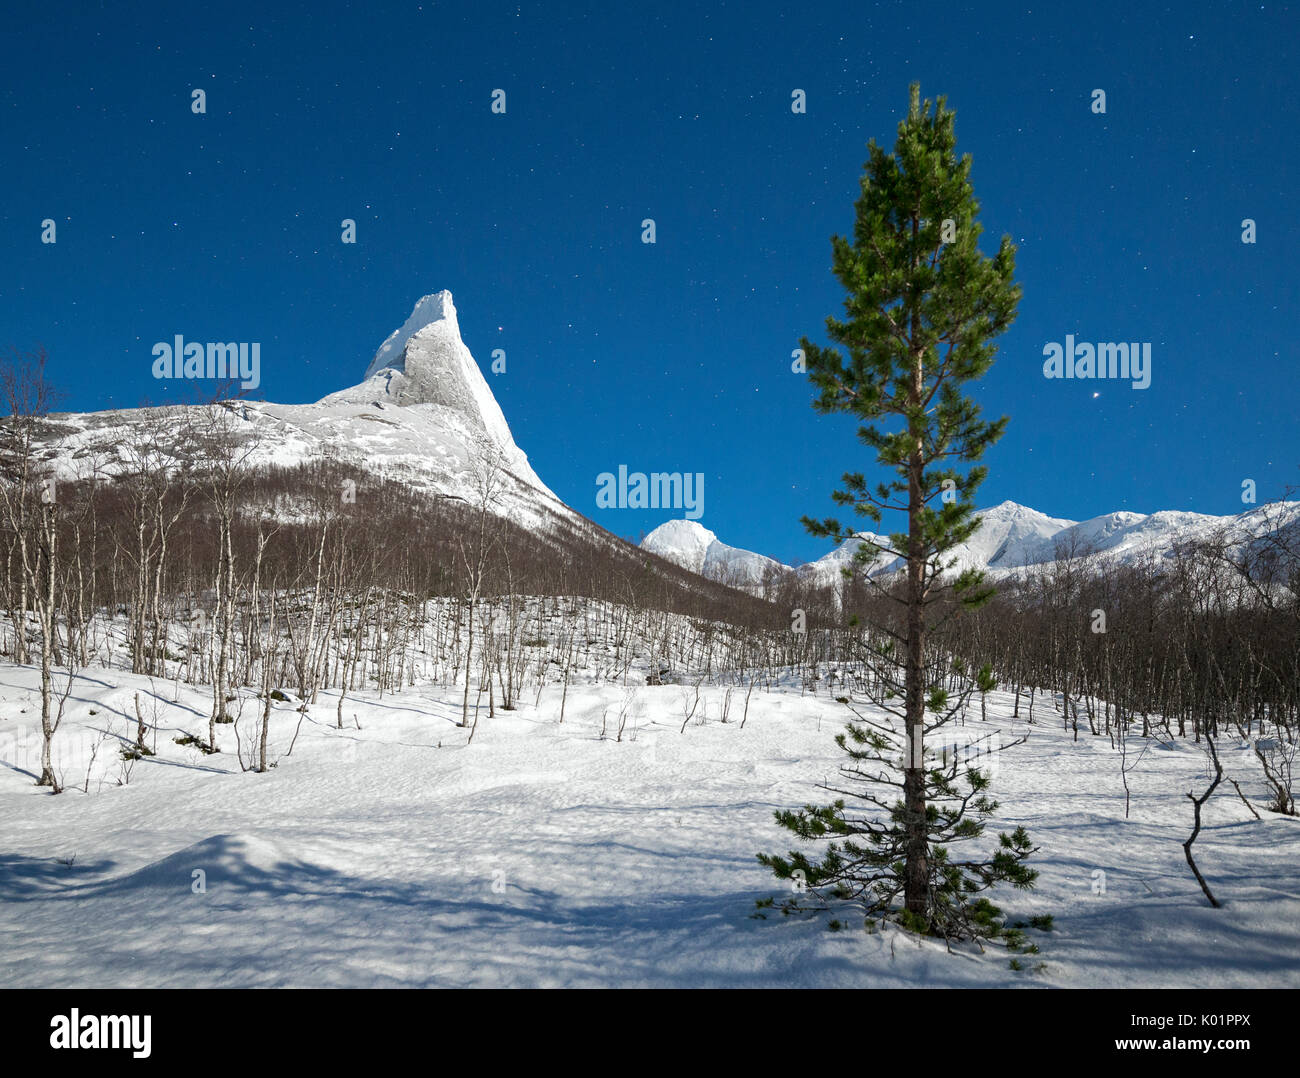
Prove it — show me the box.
[759,83,1036,938]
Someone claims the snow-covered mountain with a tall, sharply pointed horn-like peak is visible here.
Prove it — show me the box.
[27,291,766,619]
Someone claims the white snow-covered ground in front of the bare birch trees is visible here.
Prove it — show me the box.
[0,663,1300,988]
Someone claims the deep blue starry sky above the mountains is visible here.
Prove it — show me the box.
[0,0,1300,560]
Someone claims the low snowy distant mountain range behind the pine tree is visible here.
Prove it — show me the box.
[641,502,1300,589]
